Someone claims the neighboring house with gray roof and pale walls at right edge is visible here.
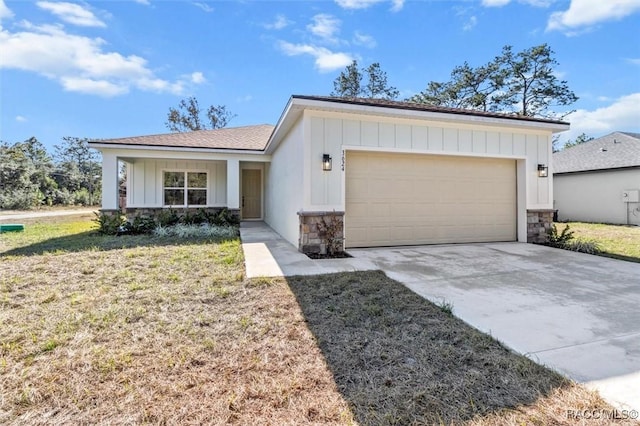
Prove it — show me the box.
[553,132,640,225]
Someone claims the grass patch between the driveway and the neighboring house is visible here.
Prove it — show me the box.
[557,222,640,262]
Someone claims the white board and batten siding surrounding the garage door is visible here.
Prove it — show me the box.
[305,111,553,210]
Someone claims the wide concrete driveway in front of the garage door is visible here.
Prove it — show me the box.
[349,243,640,410]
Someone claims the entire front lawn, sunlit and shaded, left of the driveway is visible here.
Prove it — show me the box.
[0,219,630,426]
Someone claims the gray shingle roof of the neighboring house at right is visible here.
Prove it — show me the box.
[553,132,640,174]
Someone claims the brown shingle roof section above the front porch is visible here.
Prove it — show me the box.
[91,124,274,151]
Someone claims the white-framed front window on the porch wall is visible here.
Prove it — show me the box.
[163,172,207,206]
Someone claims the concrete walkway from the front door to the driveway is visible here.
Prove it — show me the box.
[240,222,377,278]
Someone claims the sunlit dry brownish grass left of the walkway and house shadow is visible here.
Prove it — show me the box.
[0,226,351,425]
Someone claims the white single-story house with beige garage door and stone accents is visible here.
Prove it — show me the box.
[90,96,569,252]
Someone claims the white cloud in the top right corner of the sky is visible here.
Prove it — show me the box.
[547,0,640,31]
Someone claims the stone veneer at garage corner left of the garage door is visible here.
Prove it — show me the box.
[298,211,344,254]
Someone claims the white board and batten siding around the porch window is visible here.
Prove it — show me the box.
[127,159,227,208]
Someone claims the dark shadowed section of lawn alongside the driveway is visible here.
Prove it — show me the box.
[288,272,636,425]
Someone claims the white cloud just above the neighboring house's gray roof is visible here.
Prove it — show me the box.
[561,93,640,141]
